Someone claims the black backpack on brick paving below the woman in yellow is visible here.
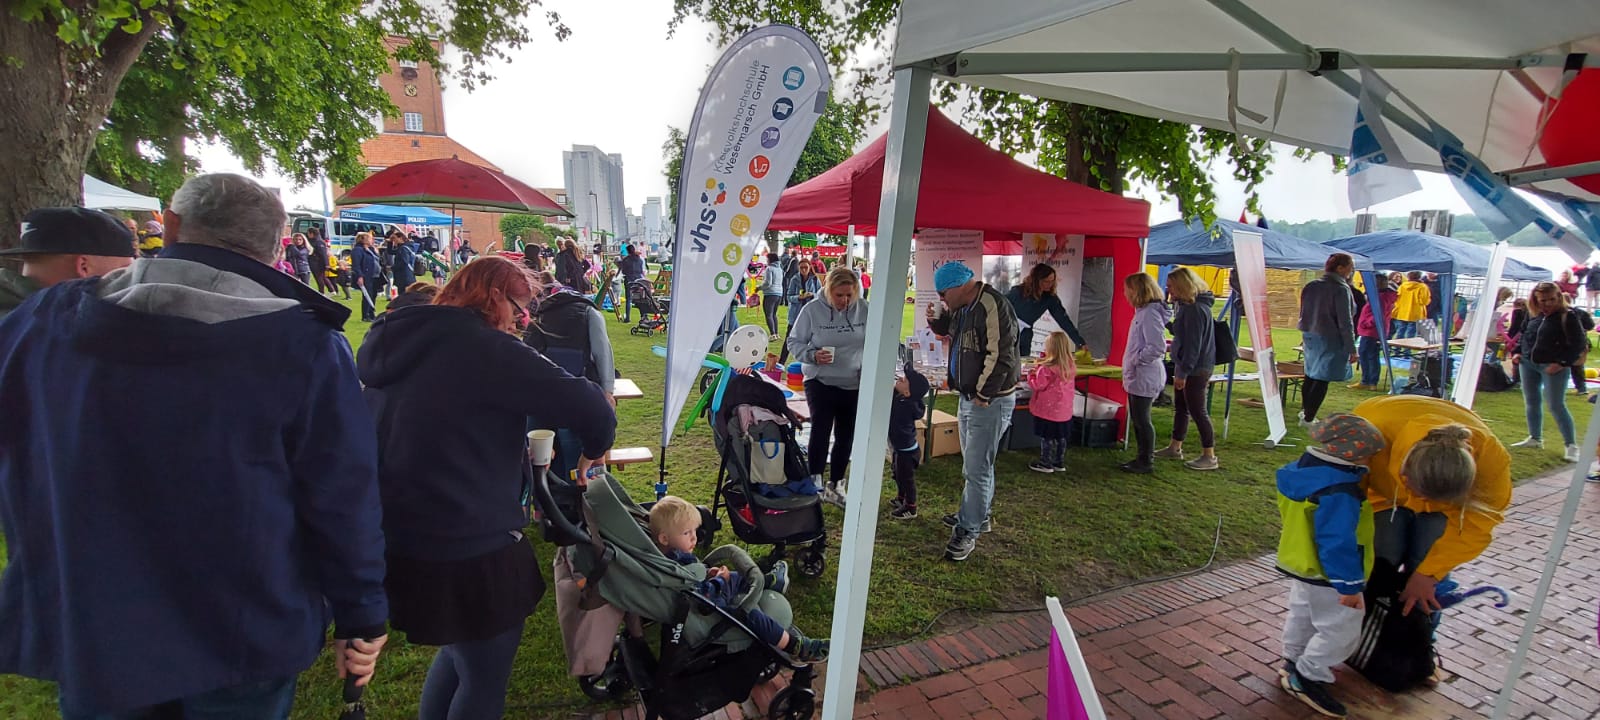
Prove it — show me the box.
[1346,558,1437,693]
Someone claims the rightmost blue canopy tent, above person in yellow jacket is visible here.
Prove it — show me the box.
[1325,230,1550,397]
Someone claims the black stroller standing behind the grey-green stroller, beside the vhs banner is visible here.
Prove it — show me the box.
[712,373,827,578]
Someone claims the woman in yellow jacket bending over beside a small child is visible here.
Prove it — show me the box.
[1352,395,1510,613]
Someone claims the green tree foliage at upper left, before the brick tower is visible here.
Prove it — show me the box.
[9,0,570,197]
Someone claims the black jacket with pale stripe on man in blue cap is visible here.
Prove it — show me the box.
[928,283,1022,402]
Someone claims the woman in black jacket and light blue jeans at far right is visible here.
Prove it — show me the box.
[1512,282,1589,462]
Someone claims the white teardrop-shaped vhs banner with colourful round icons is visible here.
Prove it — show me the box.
[661,26,834,446]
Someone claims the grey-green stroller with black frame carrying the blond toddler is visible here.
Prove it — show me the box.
[533,467,816,720]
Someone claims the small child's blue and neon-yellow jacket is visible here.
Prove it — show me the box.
[1277,450,1373,595]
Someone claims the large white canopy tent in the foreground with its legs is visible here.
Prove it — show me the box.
[822,0,1600,720]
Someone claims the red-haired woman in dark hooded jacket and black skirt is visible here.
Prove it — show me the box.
[357,256,616,720]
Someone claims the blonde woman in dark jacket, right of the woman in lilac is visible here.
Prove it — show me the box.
[1155,267,1216,470]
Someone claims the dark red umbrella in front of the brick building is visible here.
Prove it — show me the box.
[334,157,573,218]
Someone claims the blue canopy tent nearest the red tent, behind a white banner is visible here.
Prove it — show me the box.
[1144,219,1387,438]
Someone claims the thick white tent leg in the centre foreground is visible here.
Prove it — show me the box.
[822,67,936,720]
